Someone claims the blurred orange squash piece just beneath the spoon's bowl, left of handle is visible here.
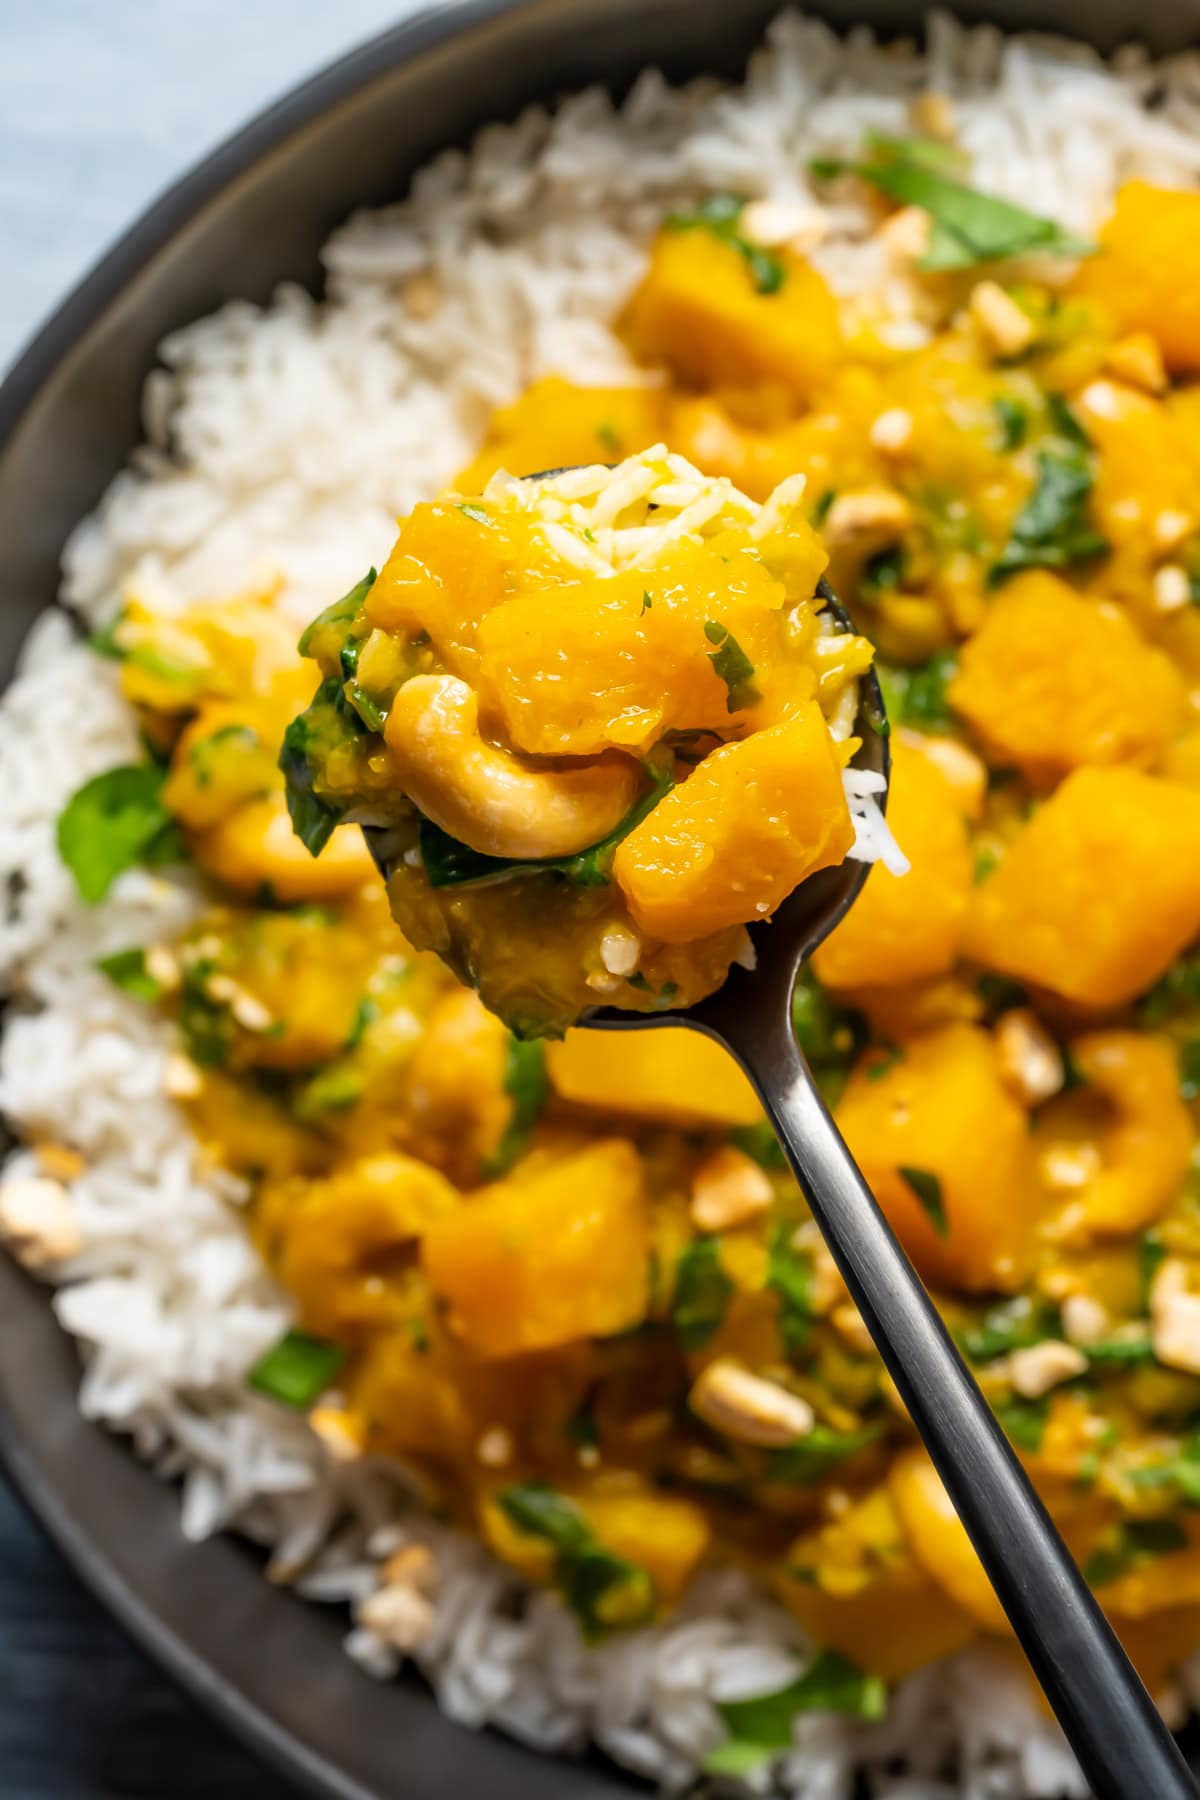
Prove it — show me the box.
[545,1030,763,1127]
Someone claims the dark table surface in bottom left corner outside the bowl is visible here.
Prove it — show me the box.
[0,1478,299,1800]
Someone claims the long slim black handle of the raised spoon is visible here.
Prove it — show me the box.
[730,1024,1200,1800]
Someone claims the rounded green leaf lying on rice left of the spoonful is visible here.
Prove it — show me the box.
[58,763,185,905]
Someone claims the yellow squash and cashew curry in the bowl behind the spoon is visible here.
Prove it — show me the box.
[79,175,1200,1690]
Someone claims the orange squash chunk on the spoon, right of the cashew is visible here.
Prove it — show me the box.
[613,702,855,943]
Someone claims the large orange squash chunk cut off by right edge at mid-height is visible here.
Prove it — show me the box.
[964,769,1200,1006]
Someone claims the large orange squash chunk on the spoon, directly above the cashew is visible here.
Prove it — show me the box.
[479,536,798,756]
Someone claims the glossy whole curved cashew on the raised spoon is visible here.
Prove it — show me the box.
[383,675,639,859]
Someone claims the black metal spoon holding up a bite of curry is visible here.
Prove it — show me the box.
[367,496,1200,1800]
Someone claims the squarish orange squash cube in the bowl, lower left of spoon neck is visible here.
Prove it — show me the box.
[421,1138,649,1357]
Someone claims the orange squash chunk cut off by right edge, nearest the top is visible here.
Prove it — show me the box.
[1072,182,1200,374]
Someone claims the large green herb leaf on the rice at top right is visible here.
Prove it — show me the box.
[810,139,1094,274]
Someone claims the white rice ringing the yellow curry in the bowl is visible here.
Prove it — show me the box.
[0,14,1200,1800]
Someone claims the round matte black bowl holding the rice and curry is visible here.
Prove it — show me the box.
[0,0,1200,1800]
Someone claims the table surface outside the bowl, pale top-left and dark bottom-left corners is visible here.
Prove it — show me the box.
[0,0,416,1800]
